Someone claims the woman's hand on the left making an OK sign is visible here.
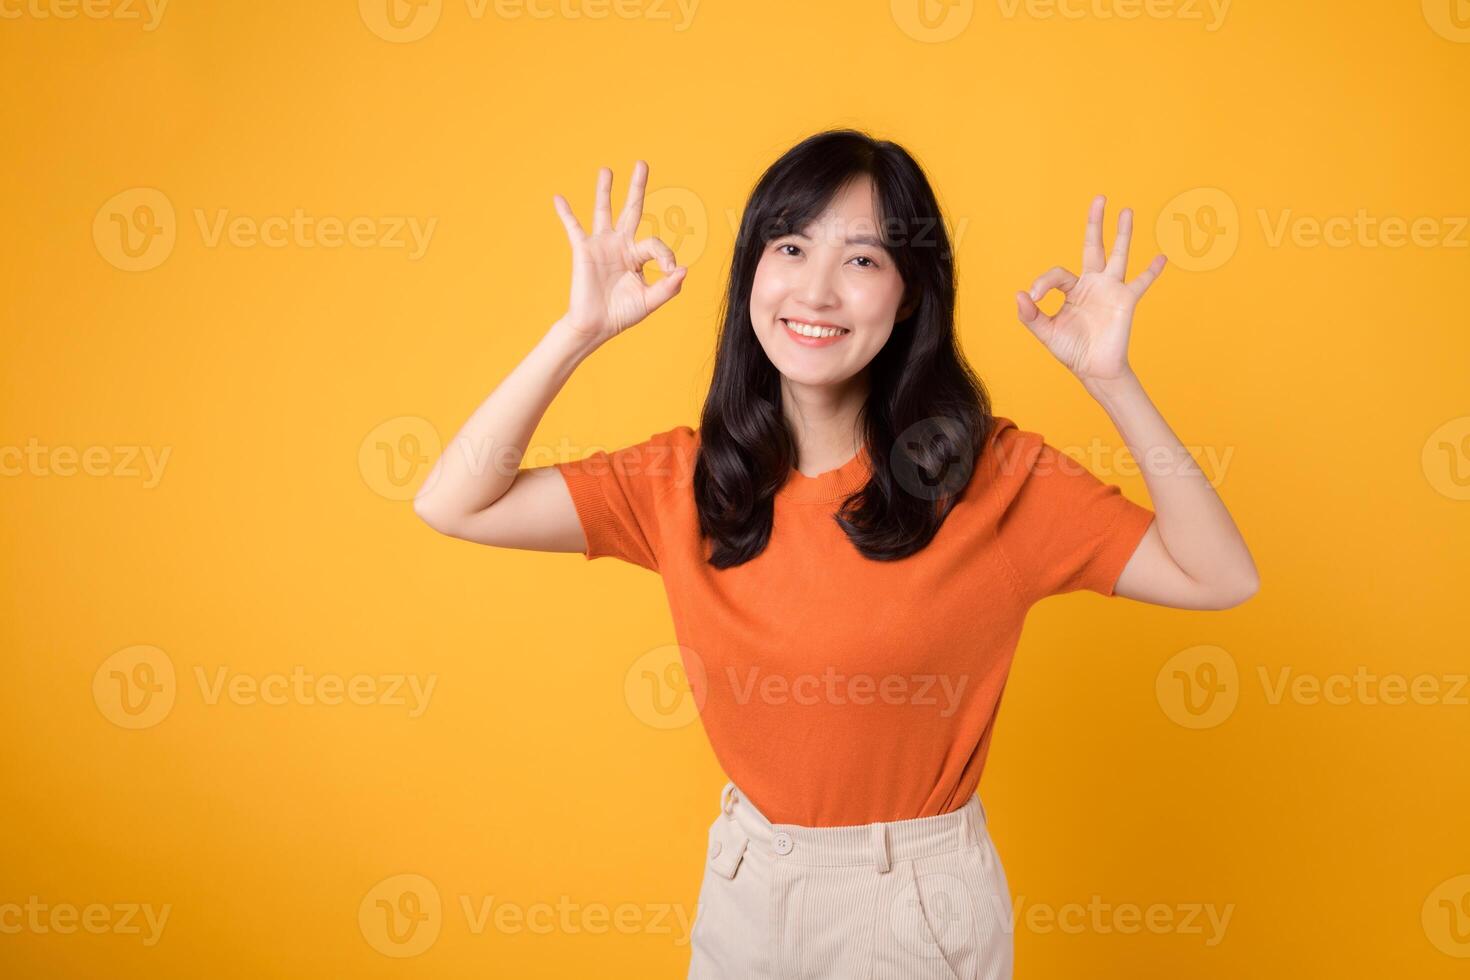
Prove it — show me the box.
[551,160,688,348]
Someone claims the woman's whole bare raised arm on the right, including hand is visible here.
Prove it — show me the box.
[1016,194,1260,610]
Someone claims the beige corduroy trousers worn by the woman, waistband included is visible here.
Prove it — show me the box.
[688,783,1014,980]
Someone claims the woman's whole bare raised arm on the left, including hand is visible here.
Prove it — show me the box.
[413,160,686,551]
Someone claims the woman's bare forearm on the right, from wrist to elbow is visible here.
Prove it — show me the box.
[1083,372,1258,594]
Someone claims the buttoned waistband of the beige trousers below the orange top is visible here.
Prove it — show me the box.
[719,782,986,871]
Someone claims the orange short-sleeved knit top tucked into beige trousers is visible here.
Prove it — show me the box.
[556,416,1154,827]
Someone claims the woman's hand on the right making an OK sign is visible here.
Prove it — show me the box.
[1016,194,1164,382]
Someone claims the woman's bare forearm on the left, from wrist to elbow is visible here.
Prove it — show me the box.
[413,320,591,522]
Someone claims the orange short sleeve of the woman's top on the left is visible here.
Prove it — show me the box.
[554,426,694,572]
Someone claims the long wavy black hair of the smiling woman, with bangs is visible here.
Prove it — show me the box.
[694,129,992,569]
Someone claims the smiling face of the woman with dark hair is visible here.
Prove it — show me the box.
[750,173,904,385]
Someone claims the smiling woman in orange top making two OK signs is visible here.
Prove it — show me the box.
[415,129,1257,980]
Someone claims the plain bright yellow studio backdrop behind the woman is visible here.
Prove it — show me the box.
[0,0,1470,979]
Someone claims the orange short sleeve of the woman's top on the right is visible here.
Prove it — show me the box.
[997,429,1154,602]
